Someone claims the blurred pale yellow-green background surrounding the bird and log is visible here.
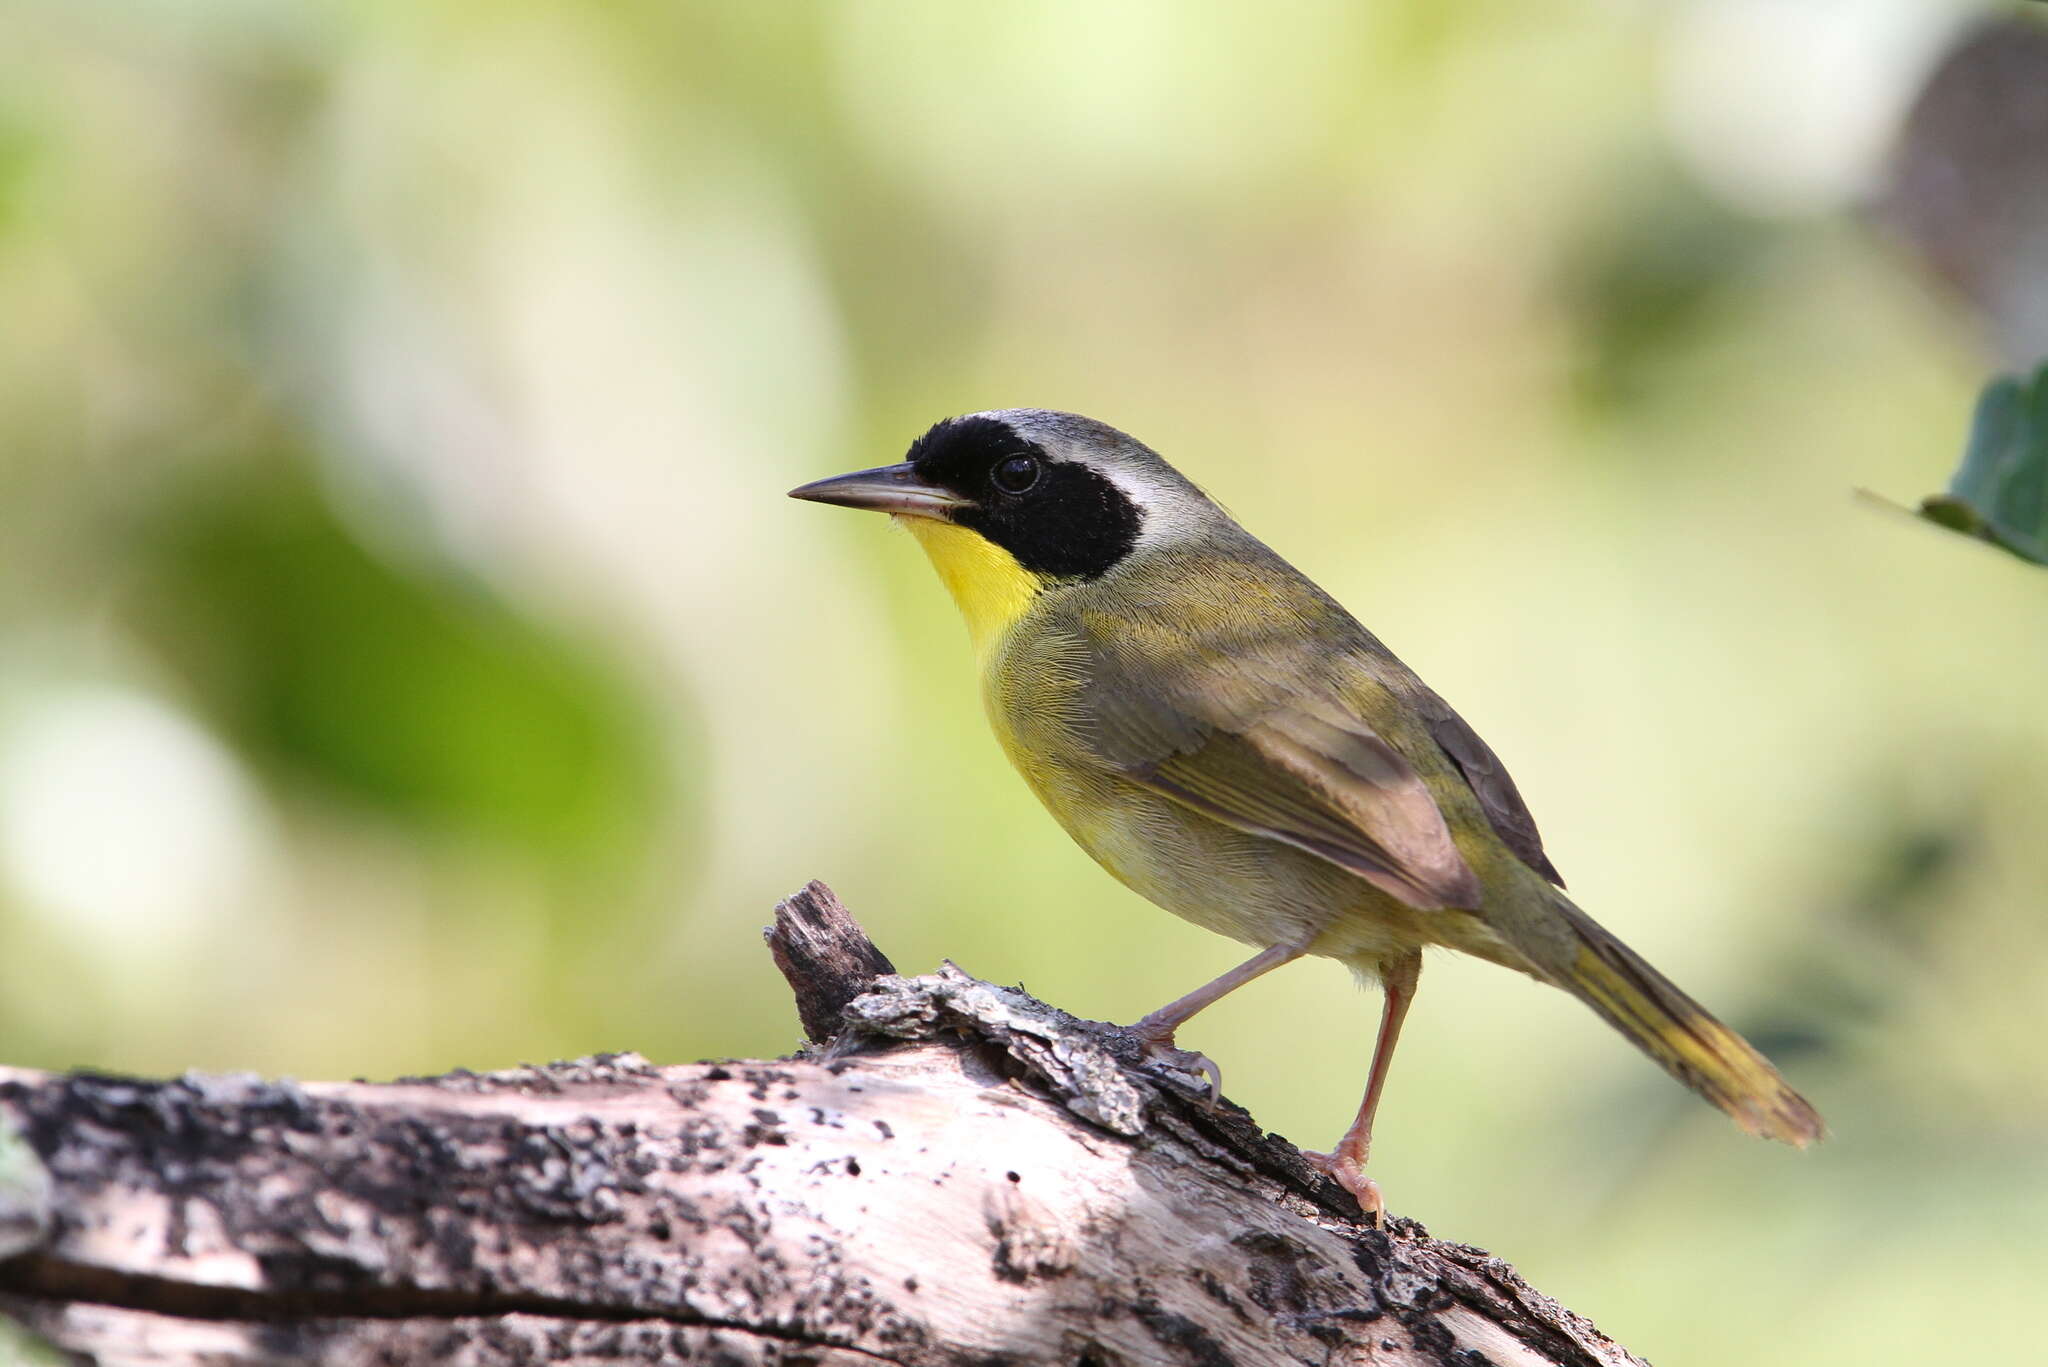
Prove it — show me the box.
[0,0,2048,1367]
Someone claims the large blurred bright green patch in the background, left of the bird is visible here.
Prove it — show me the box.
[119,443,664,867]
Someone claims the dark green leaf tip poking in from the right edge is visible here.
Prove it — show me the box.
[1919,365,2048,566]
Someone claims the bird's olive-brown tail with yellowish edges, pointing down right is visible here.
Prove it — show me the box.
[1552,894,1827,1148]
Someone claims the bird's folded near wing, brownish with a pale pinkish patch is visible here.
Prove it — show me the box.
[1094,655,1481,910]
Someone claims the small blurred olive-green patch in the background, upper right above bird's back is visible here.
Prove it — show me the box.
[1563,166,1774,418]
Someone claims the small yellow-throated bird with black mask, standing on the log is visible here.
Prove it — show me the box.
[791,408,1823,1219]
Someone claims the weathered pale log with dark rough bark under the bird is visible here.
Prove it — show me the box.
[0,883,1636,1367]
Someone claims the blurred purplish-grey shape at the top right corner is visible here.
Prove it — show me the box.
[1878,16,2048,369]
